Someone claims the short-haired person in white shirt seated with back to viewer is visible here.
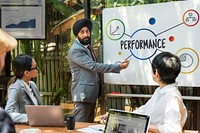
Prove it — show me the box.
[134,52,187,133]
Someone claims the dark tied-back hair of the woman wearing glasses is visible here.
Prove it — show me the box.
[8,54,32,85]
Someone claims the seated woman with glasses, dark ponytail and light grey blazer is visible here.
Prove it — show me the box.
[5,54,42,123]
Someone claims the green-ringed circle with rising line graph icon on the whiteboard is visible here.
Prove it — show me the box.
[106,19,125,40]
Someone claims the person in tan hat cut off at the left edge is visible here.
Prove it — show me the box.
[0,29,17,133]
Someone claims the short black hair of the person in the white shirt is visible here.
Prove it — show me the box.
[152,52,181,84]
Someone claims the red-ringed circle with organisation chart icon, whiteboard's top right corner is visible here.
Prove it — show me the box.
[182,9,199,27]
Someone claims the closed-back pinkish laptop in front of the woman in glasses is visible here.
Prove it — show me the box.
[25,105,65,127]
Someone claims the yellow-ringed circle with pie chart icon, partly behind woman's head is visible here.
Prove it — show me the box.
[176,48,199,74]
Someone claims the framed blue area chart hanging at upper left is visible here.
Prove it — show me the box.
[0,0,46,39]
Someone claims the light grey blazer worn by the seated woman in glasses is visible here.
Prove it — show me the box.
[5,79,42,123]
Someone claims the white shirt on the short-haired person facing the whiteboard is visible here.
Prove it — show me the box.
[134,83,187,133]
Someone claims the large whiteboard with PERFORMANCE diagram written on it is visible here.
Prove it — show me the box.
[103,0,200,87]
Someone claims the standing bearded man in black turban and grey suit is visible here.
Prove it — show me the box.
[68,19,129,122]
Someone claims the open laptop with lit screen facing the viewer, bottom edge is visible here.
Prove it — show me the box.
[104,109,150,133]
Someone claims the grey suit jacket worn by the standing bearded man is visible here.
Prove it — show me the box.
[68,40,120,103]
